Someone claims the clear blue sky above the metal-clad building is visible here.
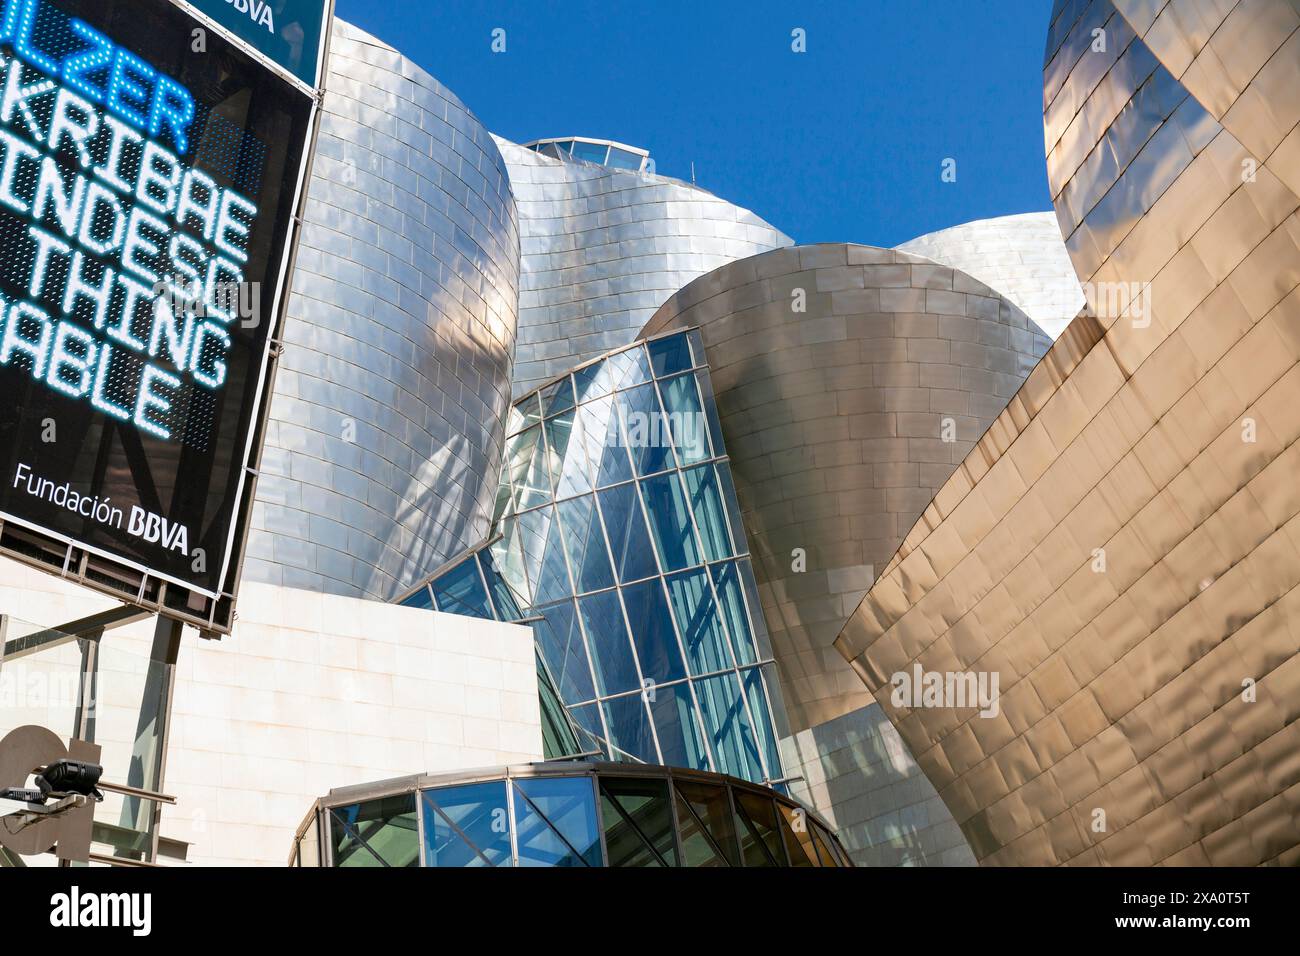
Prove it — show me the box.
[330,0,1052,246]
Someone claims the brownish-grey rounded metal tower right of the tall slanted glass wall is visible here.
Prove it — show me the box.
[645,245,1049,731]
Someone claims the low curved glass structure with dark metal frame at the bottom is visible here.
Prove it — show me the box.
[289,761,853,868]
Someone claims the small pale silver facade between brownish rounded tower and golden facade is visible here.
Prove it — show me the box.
[897,212,1084,338]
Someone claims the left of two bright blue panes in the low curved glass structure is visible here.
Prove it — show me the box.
[421,780,511,868]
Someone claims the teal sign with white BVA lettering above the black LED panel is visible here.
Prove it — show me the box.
[176,0,330,88]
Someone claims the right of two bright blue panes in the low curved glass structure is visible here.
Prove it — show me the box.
[515,777,602,866]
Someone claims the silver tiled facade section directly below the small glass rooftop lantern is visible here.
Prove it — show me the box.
[497,138,790,395]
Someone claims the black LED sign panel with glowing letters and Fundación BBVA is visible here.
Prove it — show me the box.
[0,0,313,596]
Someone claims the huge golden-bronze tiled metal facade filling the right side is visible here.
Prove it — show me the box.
[837,0,1300,865]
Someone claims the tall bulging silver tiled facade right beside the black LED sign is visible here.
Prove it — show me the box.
[244,22,519,600]
